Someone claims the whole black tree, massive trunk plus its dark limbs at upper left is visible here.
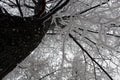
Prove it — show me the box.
[0,0,69,79]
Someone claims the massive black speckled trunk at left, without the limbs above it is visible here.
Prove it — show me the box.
[0,14,51,80]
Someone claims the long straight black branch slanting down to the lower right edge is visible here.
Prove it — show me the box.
[69,34,113,80]
